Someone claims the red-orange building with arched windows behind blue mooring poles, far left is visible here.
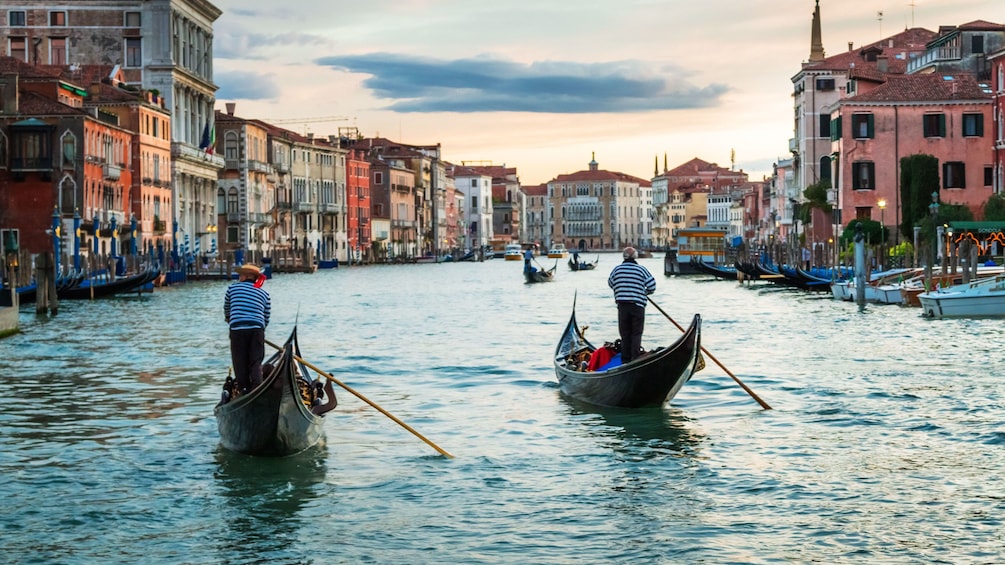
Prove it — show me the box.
[0,57,134,265]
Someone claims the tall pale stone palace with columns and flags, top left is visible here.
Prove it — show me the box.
[0,0,223,251]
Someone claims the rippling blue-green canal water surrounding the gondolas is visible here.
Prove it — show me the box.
[0,254,1005,564]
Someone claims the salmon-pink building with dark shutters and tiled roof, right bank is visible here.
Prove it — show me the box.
[832,72,994,229]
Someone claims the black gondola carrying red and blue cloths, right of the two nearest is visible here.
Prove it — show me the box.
[555,305,705,408]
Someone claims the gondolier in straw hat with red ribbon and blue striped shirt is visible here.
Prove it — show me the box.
[223,264,271,393]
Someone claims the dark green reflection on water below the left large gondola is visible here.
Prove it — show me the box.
[213,439,329,561]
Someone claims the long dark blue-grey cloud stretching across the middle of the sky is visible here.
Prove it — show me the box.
[315,53,729,114]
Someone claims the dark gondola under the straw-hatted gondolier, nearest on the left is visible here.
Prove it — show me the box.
[213,328,338,456]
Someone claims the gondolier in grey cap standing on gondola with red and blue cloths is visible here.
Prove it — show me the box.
[607,246,656,363]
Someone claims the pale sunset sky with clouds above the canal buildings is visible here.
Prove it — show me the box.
[213,0,1005,185]
